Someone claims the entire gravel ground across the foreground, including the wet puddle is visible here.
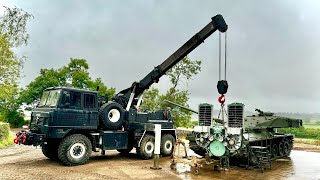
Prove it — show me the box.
[0,145,320,180]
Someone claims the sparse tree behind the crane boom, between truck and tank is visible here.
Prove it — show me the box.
[141,57,201,127]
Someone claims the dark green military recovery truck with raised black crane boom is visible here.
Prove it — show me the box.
[15,15,228,166]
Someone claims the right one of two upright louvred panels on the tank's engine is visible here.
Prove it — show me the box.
[228,103,244,127]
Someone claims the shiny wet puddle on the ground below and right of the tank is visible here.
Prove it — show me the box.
[169,151,320,180]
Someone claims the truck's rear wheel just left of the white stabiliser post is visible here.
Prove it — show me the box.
[137,134,155,159]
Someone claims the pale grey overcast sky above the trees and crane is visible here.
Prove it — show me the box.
[0,0,320,112]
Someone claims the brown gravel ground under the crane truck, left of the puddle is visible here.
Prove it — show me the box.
[0,145,179,180]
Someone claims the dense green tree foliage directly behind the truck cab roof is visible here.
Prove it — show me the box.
[20,58,115,104]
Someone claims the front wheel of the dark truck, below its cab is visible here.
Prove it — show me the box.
[58,134,92,166]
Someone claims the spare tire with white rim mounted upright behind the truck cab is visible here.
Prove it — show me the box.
[99,102,124,129]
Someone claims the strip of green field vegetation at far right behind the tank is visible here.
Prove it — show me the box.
[278,127,320,140]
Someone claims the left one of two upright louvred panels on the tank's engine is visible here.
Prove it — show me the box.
[199,104,213,126]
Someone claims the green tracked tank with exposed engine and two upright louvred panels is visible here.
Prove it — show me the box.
[187,103,302,166]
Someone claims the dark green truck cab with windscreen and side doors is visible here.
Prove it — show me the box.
[30,87,98,143]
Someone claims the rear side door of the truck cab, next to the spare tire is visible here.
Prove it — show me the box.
[83,93,98,128]
